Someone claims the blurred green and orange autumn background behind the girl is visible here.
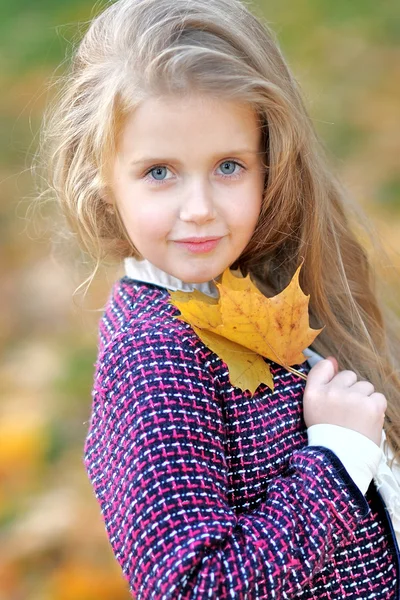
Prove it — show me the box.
[0,0,400,600]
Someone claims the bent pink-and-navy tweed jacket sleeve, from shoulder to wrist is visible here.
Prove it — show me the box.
[84,330,369,600]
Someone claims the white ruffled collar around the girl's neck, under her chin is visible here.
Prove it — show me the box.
[124,256,218,298]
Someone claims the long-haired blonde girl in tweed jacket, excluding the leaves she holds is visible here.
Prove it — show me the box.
[38,0,400,600]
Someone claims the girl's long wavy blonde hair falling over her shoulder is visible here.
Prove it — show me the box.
[36,0,400,453]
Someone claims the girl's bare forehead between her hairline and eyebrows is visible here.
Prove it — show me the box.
[119,95,261,154]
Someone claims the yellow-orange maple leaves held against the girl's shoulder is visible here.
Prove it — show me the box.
[170,265,322,394]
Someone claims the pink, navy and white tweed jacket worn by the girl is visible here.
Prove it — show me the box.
[84,277,399,600]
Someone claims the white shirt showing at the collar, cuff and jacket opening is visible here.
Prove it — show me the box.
[124,257,400,544]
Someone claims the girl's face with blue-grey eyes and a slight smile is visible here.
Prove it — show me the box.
[111,95,264,283]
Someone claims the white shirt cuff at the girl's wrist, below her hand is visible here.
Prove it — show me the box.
[307,423,383,494]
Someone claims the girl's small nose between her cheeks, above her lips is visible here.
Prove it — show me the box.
[180,181,216,224]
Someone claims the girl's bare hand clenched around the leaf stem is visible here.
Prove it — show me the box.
[303,357,387,446]
